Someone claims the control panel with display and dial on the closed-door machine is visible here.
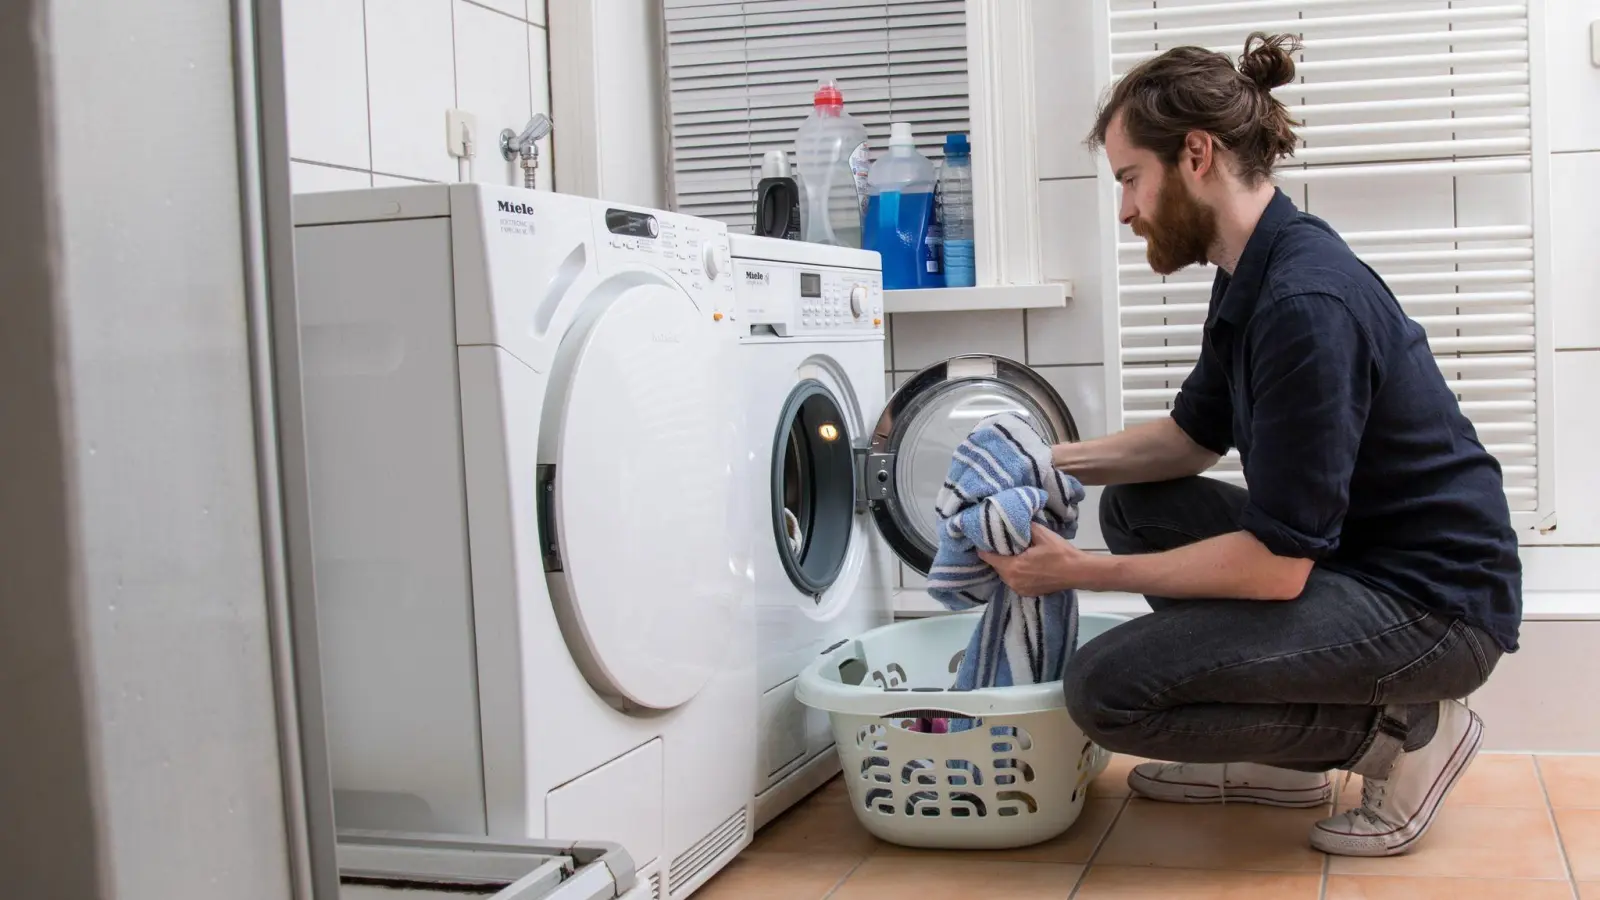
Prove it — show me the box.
[595,207,734,322]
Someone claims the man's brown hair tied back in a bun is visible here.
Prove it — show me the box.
[1088,32,1301,184]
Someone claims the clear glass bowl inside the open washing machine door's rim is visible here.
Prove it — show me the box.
[894,381,1051,554]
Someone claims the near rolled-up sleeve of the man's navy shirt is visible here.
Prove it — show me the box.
[1240,295,1381,559]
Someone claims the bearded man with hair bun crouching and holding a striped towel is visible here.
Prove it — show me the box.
[987,34,1522,857]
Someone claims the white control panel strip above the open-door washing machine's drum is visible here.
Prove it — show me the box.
[733,258,883,336]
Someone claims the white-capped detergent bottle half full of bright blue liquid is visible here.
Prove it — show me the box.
[861,122,944,290]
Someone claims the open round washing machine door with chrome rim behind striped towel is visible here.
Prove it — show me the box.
[866,354,1078,575]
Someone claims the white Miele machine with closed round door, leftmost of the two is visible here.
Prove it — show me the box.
[294,184,757,897]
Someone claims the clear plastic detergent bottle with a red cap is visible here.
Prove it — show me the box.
[795,78,867,247]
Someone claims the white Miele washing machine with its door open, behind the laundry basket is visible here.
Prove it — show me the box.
[731,234,1078,828]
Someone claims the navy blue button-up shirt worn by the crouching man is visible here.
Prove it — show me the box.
[1173,191,1522,652]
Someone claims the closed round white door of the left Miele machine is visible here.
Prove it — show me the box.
[539,271,738,709]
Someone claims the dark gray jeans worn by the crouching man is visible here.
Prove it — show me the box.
[1064,477,1501,778]
